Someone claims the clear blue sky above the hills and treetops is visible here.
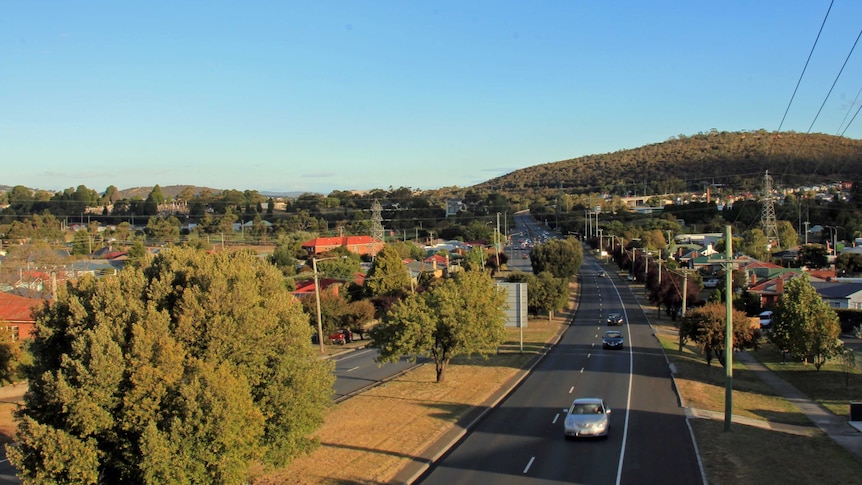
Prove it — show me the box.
[0,0,862,193]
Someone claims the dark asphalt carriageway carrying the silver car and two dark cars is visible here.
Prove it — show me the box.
[419,255,702,485]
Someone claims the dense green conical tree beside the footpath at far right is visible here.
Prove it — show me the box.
[769,276,842,370]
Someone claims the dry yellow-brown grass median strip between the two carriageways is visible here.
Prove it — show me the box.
[254,316,566,485]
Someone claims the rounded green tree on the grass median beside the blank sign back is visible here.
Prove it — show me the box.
[371,271,506,382]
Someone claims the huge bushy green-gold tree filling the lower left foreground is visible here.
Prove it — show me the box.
[9,248,333,483]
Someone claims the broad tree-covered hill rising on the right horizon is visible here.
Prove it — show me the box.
[475,130,862,195]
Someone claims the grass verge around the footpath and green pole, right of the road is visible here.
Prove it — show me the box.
[657,326,862,485]
